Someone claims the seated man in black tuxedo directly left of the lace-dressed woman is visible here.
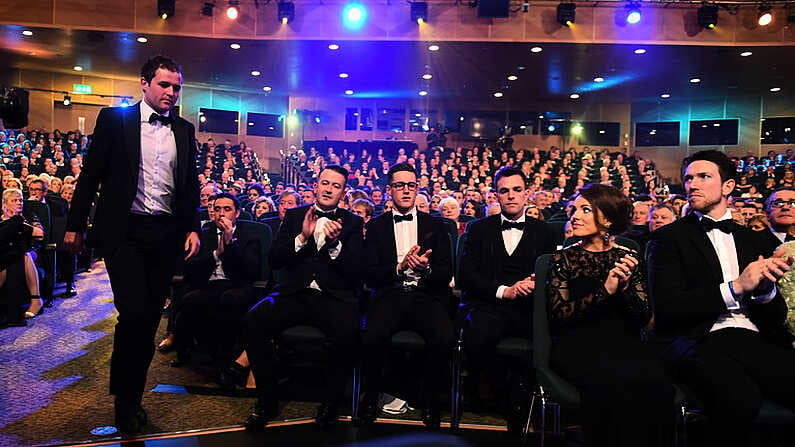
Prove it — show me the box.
[459,166,556,428]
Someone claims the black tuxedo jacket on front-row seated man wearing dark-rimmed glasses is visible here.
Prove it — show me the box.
[365,211,453,300]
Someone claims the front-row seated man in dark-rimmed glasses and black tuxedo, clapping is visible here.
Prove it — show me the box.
[361,163,454,428]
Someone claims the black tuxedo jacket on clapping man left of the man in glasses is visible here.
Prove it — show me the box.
[270,205,364,302]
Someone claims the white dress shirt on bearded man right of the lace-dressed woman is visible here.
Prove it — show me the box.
[696,210,776,332]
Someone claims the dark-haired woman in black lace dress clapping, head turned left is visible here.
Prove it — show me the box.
[547,184,674,447]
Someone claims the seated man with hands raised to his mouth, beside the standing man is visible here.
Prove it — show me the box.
[172,192,268,372]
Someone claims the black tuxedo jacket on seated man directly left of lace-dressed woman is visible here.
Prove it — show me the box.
[459,214,556,307]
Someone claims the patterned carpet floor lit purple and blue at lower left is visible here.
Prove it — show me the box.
[0,262,502,447]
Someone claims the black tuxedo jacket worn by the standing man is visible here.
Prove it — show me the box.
[66,103,200,251]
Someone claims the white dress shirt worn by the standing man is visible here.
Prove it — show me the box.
[130,101,177,214]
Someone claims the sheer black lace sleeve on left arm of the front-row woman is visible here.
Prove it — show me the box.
[547,251,610,324]
